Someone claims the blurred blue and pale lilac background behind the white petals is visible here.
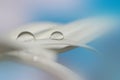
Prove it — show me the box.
[0,0,120,80]
